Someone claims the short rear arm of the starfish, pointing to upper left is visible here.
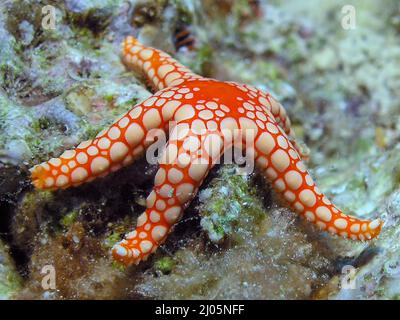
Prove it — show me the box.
[122,37,201,90]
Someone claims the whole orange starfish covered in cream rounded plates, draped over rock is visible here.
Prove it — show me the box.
[31,37,383,265]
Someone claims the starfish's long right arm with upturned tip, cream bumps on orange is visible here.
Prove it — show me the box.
[255,123,382,240]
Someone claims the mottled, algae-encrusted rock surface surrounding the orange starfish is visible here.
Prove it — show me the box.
[0,0,400,299]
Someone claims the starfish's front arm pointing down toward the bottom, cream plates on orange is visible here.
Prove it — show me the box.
[112,129,222,265]
